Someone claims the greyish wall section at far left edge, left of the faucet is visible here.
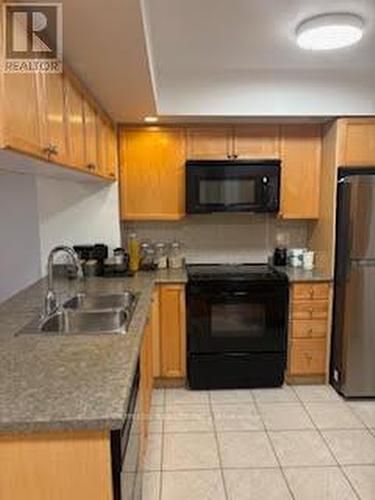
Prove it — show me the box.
[0,171,40,302]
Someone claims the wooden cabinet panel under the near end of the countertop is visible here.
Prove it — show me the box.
[0,430,113,500]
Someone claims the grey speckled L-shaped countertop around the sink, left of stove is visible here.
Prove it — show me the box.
[0,270,187,432]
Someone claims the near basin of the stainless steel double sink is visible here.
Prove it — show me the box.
[41,309,130,335]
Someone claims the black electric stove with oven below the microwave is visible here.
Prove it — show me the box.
[186,264,288,389]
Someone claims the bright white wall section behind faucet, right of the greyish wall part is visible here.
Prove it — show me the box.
[36,177,121,274]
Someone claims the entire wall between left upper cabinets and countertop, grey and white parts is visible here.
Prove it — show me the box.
[0,170,121,302]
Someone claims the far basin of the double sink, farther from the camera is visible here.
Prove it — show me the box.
[63,291,137,311]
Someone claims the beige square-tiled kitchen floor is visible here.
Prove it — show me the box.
[143,386,375,500]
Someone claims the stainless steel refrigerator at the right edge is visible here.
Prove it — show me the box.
[331,167,375,397]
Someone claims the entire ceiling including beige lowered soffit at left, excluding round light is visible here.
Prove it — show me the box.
[19,0,375,122]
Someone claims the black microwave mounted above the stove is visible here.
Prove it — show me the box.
[186,160,280,214]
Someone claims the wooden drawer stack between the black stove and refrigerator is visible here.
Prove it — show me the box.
[288,283,330,377]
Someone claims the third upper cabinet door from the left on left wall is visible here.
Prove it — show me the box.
[64,78,85,168]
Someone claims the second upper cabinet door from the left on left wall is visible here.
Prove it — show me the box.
[41,73,69,164]
